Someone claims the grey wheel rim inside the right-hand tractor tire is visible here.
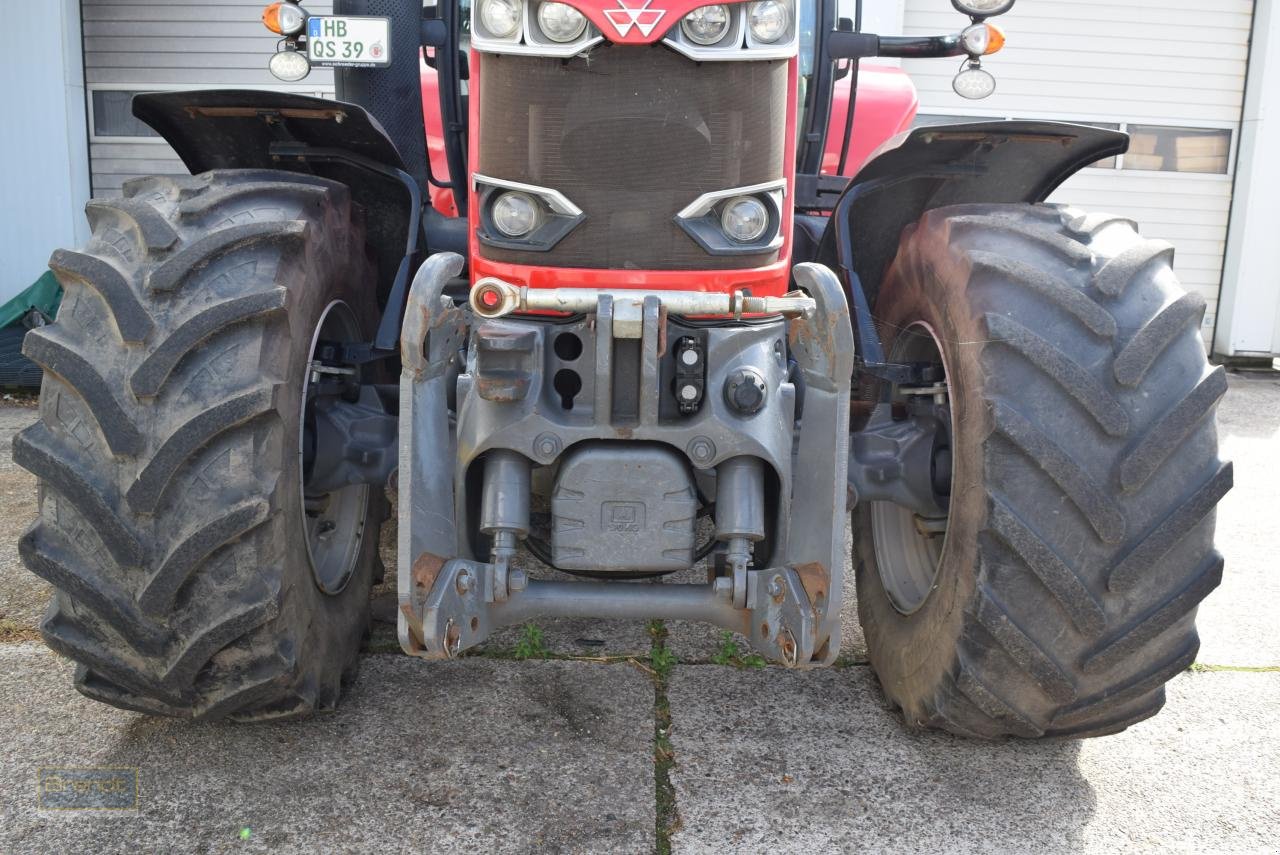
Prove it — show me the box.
[870,321,955,614]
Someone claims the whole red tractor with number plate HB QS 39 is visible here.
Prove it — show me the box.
[14,0,1231,739]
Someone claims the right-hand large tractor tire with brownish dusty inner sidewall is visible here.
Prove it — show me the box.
[854,205,1231,739]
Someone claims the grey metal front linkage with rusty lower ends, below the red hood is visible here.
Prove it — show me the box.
[398,253,854,667]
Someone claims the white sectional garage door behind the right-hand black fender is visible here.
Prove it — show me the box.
[904,0,1253,338]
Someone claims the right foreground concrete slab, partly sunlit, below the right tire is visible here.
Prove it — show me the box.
[668,667,1280,854]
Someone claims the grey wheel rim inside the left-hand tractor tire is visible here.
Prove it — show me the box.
[298,301,370,595]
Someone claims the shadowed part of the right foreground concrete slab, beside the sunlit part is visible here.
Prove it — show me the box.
[669,667,1096,852]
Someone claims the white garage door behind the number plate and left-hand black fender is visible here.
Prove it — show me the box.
[82,0,333,196]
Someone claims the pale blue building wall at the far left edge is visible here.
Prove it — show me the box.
[0,0,88,303]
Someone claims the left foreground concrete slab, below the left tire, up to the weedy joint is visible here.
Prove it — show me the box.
[0,644,654,854]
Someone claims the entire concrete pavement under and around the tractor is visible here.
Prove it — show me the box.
[0,375,1280,852]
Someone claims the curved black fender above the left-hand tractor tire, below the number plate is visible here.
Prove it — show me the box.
[133,90,435,298]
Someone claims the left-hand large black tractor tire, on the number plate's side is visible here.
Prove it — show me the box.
[14,172,385,719]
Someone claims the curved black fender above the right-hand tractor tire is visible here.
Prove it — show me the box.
[818,122,1129,306]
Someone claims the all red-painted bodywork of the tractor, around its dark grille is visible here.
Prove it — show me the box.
[422,15,918,296]
